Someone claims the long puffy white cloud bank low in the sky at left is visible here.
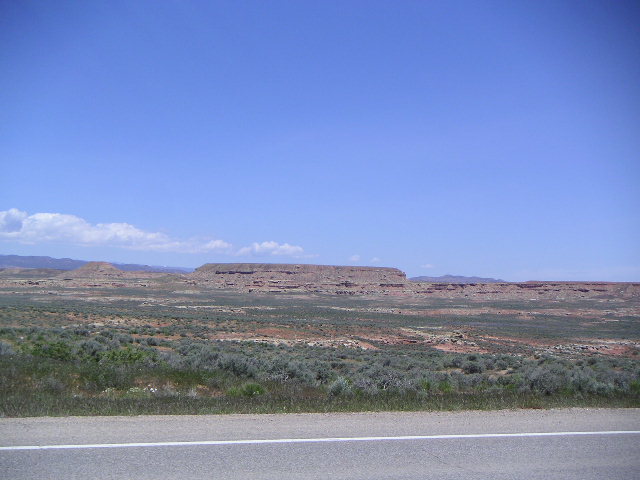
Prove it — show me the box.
[0,208,307,258]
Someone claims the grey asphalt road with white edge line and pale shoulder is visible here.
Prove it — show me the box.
[0,409,640,480]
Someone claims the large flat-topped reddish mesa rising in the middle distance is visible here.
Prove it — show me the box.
[189,263,407,289]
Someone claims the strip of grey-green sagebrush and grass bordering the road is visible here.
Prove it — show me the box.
[0,327,640,416]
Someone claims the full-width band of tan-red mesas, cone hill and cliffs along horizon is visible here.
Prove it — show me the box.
[0,262,640,300]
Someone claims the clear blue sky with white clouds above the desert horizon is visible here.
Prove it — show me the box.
[0,0,640,281]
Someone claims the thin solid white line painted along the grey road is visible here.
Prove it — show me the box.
[0,430,640,451]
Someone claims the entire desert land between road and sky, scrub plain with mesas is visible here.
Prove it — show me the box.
[0,262,640,416]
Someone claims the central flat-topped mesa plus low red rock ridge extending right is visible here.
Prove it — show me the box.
[182,263,640,301]
